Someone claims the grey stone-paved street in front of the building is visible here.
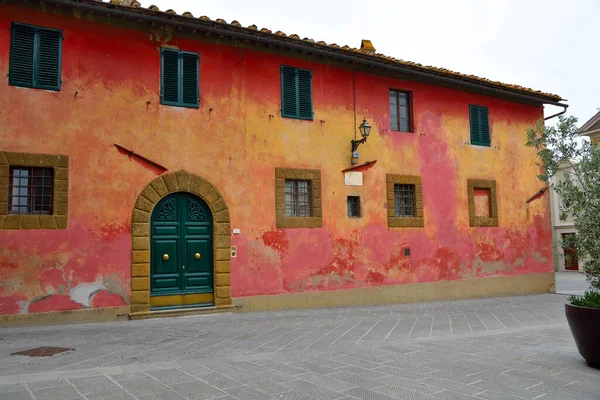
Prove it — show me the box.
[0,294,600,400]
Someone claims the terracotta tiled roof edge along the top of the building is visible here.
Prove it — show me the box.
[72,0,563,101]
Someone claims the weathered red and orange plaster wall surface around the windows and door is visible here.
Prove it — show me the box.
[0,4,553,314]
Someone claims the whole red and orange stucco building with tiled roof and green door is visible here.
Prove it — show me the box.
[0,0,562,323]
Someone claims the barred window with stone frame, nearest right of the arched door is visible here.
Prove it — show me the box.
[275,168,323,228]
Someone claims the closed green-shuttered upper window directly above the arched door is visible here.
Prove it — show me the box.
[160,48,200,108]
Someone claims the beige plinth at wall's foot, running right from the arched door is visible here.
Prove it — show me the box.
[233,272,555,312]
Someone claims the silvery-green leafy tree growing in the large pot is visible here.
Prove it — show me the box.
[527,116,600,308]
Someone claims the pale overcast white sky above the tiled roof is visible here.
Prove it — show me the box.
[141,0,600,126]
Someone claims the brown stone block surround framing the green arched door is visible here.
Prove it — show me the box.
[130,170,232,315]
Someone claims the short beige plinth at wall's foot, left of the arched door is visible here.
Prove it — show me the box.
[0,306,129,328]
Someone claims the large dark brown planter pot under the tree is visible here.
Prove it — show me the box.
[565,304,600,368]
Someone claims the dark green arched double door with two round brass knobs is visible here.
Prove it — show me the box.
[150,193,213,308]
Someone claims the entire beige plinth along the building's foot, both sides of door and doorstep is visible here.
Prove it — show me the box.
[0,272,555,327]
